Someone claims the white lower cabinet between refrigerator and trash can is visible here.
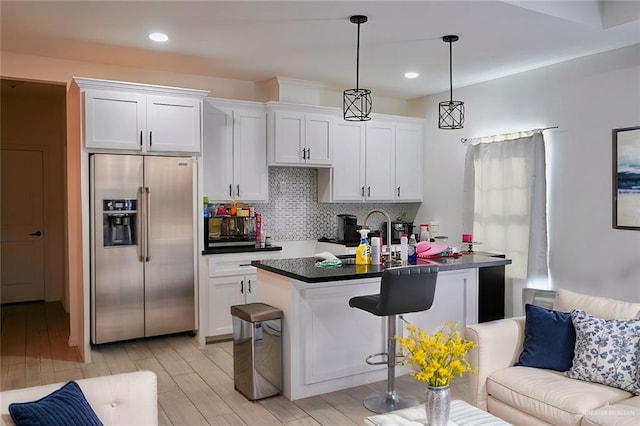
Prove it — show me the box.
[200,251,280,342]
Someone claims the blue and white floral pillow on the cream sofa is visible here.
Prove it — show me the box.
[565,309,640,395]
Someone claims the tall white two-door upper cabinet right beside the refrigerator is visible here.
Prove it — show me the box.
[202,98,269,202]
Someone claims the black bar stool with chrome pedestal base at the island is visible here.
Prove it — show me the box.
[349,265,438,413]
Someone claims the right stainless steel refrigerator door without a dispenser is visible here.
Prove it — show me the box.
[144,156,196,336]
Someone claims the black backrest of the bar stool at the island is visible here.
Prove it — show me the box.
[377,265,438,316]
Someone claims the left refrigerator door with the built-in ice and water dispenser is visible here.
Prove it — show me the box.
[90,154,144,344]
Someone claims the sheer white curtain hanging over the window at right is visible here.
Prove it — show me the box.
[463,129,548,316]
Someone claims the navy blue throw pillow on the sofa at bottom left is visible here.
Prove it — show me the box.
[9,381,102,426]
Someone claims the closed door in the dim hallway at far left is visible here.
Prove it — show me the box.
[0,149,45,303]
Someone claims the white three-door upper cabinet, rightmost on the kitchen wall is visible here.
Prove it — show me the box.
[318,116,423,202]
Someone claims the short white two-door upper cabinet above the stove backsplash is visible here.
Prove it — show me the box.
[267,102,334,167]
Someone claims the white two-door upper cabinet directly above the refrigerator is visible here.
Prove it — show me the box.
[74,78,209,154]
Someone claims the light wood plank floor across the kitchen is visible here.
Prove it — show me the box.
[0,303,466,426]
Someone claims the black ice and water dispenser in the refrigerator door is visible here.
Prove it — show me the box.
[102,199,138,247]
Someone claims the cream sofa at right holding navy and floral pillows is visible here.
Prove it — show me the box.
[464,289,640,426]
